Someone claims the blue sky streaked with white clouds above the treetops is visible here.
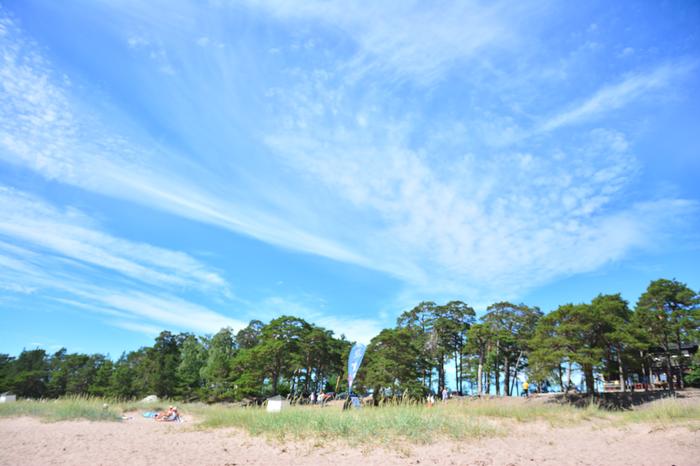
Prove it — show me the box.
[0,0,700,356]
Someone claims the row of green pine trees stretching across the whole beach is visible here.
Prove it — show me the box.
[0,279,700,402]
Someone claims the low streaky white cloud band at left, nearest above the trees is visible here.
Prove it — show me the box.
[0,187,243,334]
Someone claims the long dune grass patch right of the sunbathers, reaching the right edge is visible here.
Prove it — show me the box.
[193,398,700,443]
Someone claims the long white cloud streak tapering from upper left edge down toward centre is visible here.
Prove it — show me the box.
[0,10,363,272]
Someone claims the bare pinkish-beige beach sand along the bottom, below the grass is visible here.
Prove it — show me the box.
[0,415,700,466]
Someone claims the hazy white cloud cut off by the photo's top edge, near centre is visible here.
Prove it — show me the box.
[241,0,520,84]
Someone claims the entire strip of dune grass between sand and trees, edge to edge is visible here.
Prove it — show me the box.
[0,397,700,444]
